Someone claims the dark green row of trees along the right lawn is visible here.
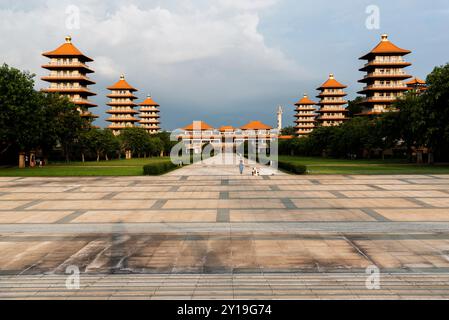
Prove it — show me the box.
[279,64,449,163]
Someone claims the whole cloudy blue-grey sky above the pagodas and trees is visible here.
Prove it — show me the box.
[0,0,449,130]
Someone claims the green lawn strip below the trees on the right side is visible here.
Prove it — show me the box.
[279,156,449,175]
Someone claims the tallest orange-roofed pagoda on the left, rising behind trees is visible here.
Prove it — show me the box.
[41,36,98,120]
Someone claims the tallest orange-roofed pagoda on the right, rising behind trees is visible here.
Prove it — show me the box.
[359,34,411,115]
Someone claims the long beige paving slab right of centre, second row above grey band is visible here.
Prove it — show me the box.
[292,198,420,209]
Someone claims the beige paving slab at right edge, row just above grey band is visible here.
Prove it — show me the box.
[375,209,449,221]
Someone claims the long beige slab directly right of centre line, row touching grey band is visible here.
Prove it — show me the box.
[230,209,375,222]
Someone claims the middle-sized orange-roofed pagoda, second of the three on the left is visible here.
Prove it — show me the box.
[106,75,139,135]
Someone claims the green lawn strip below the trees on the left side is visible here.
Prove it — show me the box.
[0,158,169,177]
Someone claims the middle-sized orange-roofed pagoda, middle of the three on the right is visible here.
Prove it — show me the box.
[317,74,348,127]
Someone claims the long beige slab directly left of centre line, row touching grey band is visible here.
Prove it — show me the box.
[72,210,217,223]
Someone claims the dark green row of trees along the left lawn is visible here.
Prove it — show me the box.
[0,64,173,164]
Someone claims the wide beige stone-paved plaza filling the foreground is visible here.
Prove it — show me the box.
[0,158,449,299]
